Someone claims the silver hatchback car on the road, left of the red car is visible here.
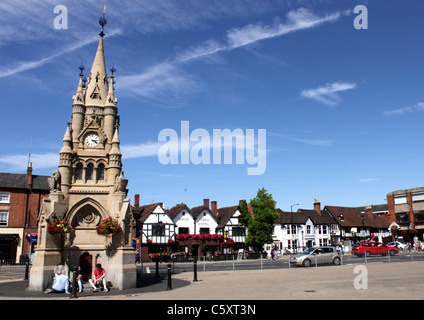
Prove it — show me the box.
[290,247,341,267]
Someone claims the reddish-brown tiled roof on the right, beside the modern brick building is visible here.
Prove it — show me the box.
[323,206,389,229]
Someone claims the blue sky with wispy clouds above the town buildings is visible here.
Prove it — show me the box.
[0,0,424,210]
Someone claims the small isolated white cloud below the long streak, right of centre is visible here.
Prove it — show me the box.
[300,81,356,107]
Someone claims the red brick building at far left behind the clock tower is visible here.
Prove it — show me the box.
[0,163,50,262]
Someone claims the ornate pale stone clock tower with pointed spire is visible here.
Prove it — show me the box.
[29,13,136,291]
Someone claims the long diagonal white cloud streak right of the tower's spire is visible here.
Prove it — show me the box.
[120,8,343,101]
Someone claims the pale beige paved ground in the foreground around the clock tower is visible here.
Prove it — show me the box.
[0,261,424,303]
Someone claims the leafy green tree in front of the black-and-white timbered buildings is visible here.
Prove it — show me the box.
[246,188,279,251]
